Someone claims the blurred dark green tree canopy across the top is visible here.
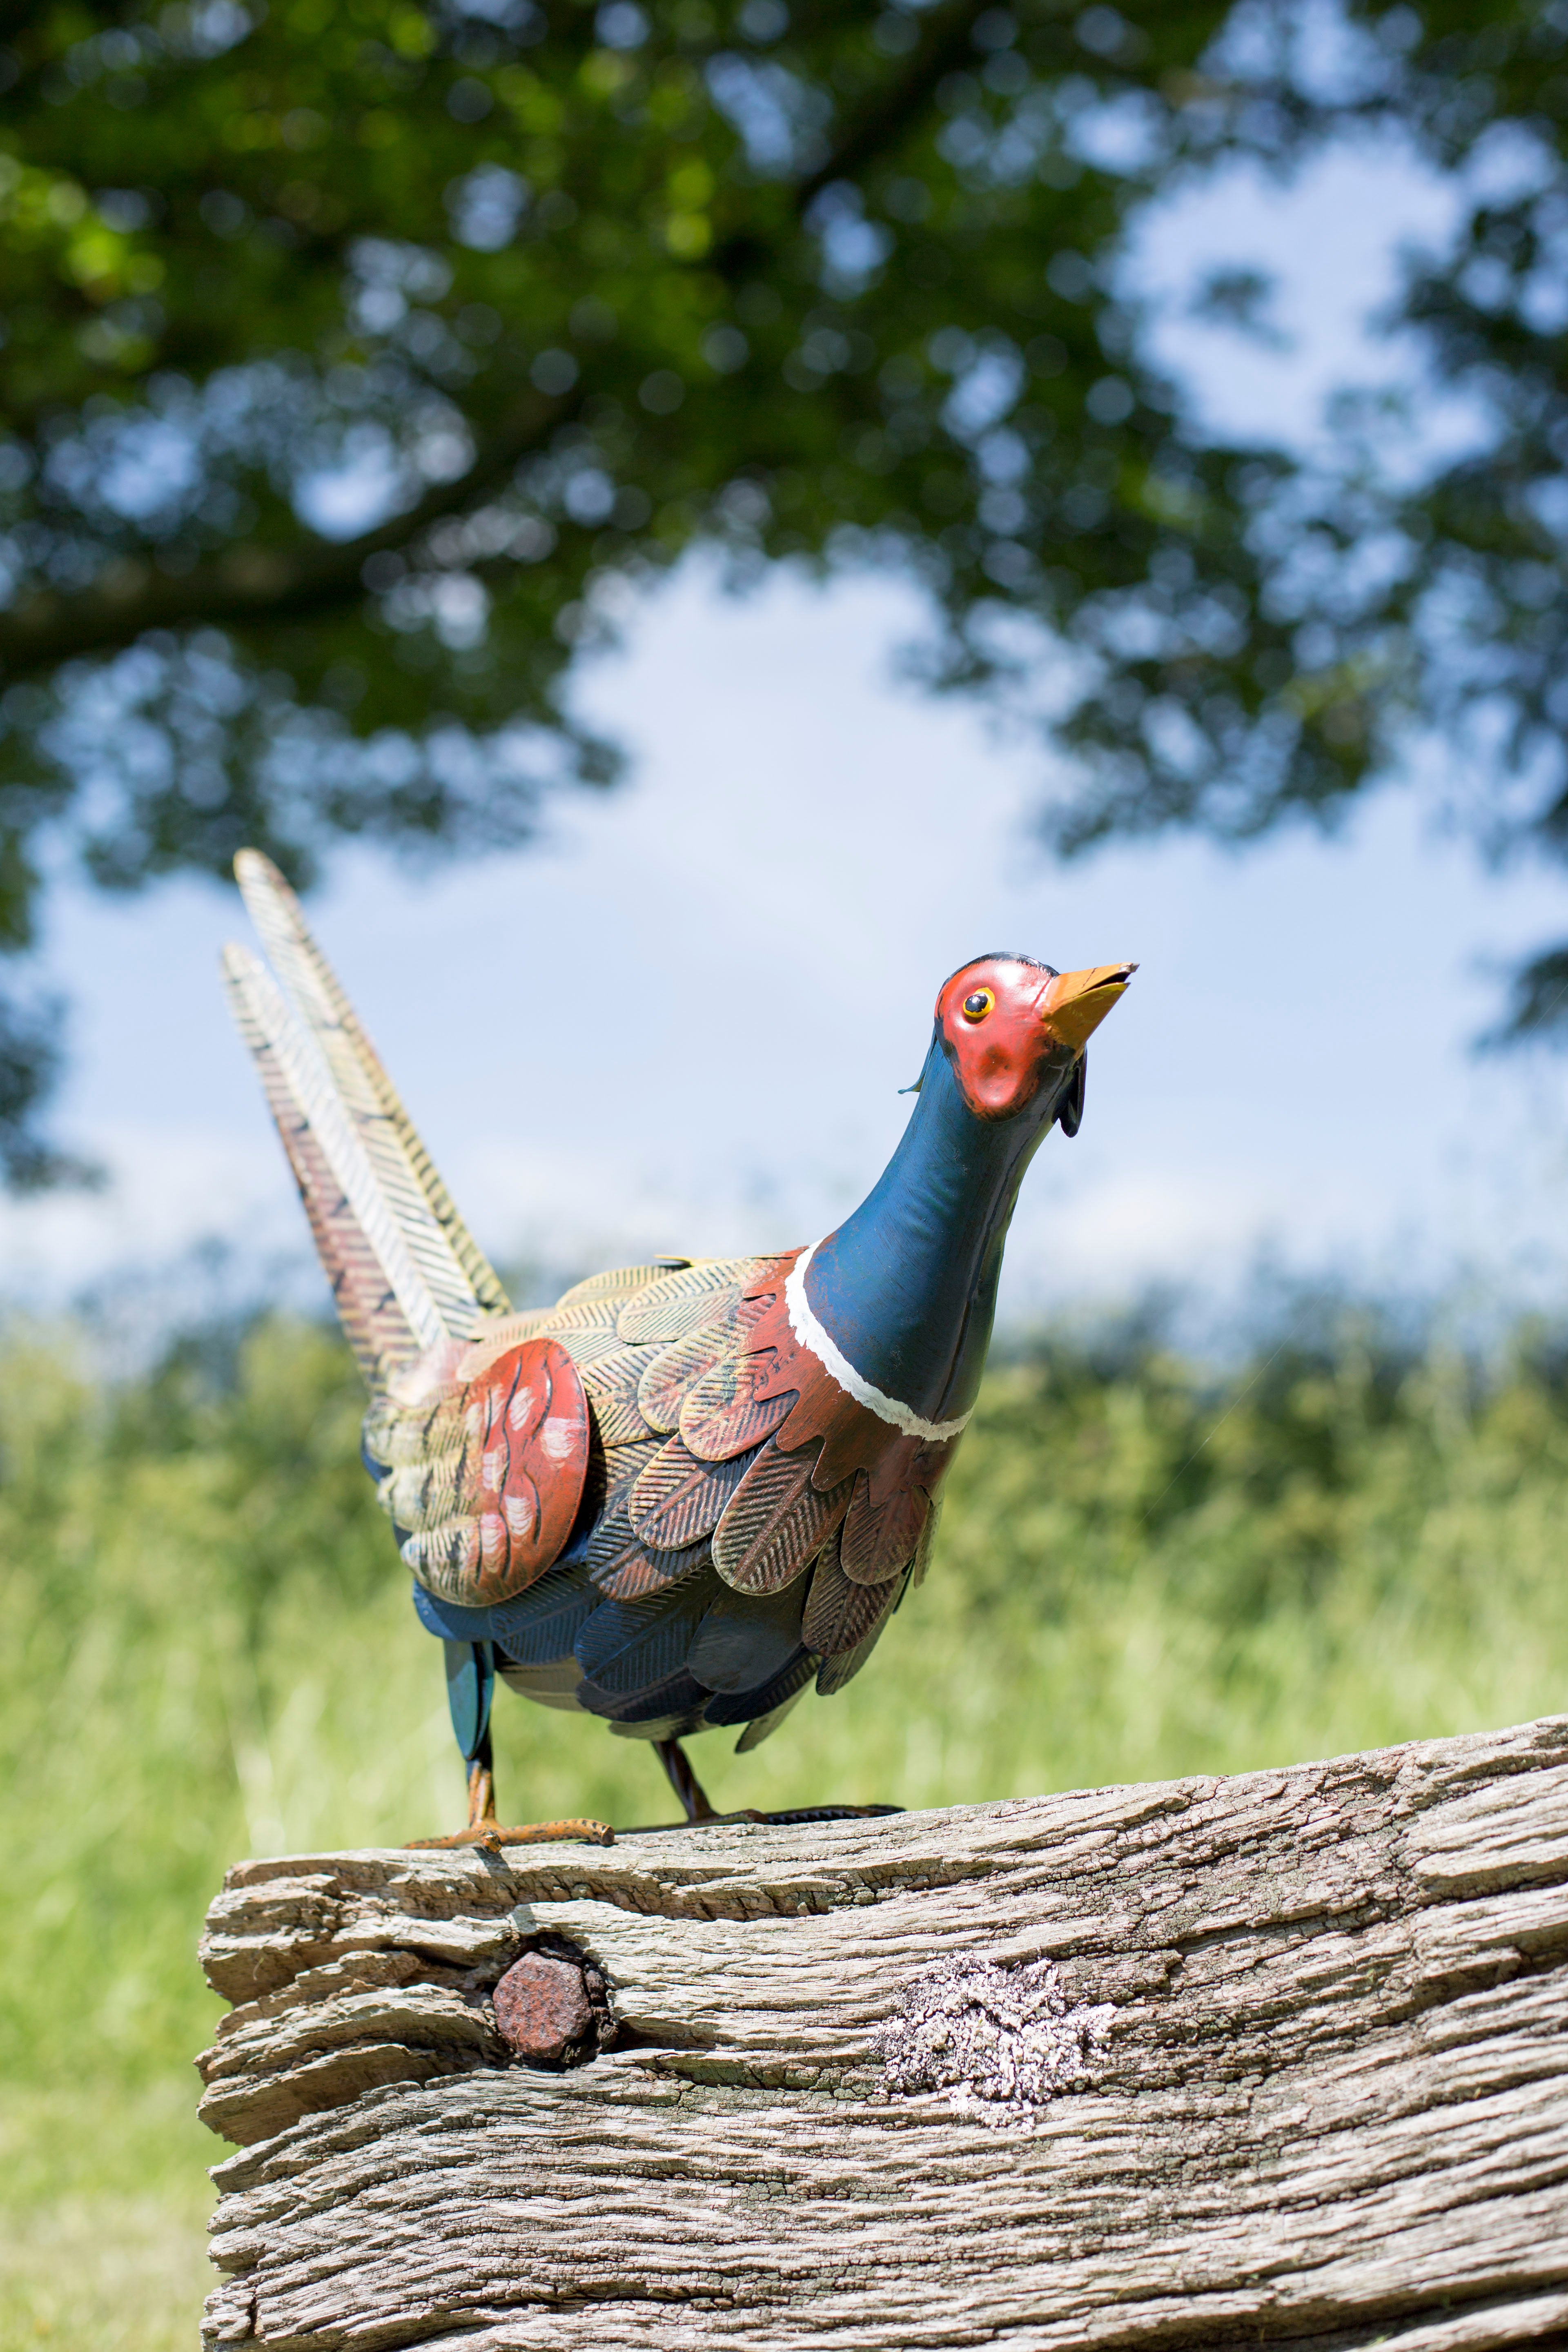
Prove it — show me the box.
[0,0,1568,1183]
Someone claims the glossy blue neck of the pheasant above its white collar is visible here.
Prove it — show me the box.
[806,1040,1069,1421]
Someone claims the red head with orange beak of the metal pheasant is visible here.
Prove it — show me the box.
[935,955,1138,1120]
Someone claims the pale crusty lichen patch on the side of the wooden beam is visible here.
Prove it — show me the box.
[872,1955,1112,2126]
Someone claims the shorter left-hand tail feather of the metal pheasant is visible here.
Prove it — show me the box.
[223,948,454,1388]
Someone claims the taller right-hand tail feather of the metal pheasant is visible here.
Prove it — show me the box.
[235,849,508,1336]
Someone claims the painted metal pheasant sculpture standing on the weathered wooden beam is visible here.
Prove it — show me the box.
[223,849,1136,1846]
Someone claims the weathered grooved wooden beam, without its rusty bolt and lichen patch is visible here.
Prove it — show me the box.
[202,1717,1568,2352]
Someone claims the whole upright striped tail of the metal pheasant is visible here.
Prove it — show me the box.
[223,849,506,1390]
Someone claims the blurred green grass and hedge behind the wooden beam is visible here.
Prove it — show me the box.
[0,1317,1568,2352]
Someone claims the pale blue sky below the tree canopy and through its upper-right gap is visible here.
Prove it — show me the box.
[12,137,1568,1312]
